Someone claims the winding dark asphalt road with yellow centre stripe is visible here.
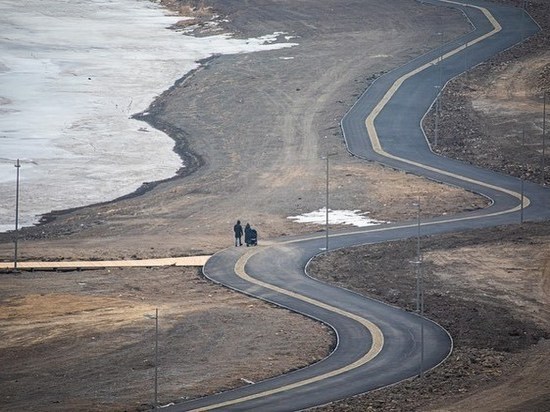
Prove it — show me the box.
[164,0,550,411]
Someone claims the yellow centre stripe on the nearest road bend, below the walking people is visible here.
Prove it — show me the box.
[193,248,384,411]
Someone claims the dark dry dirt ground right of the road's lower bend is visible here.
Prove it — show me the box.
[309,223,550,411]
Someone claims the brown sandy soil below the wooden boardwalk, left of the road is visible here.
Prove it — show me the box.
[0,268,333,411]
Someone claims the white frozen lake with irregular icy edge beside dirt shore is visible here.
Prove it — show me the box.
[0,0,295,231]
